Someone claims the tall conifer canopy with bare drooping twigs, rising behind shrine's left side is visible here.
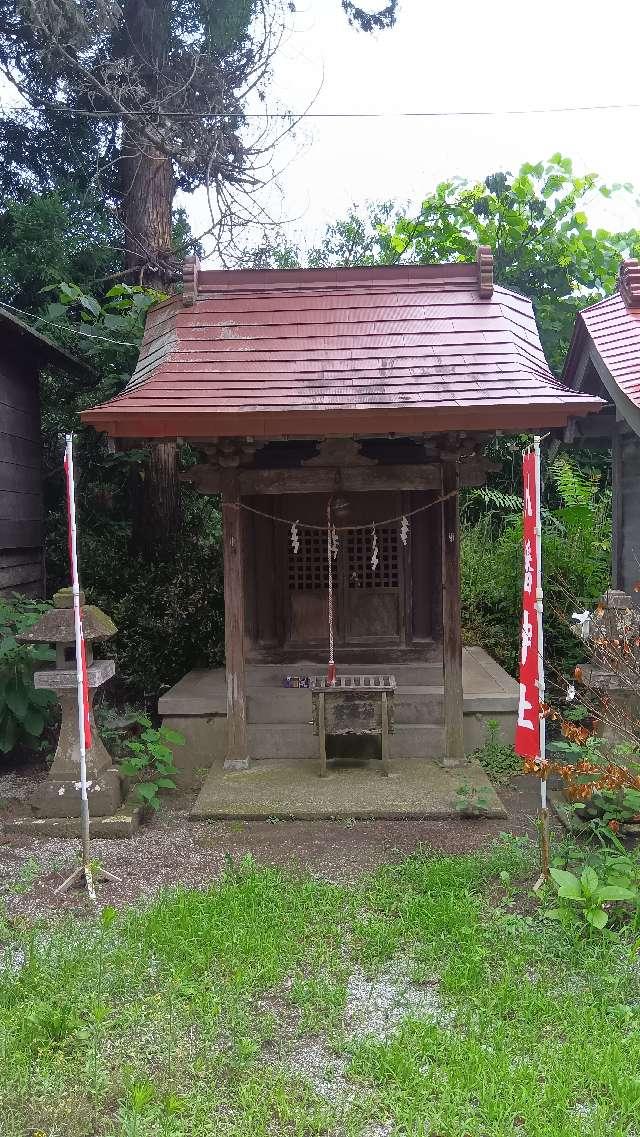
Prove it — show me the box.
[0,0,397,287]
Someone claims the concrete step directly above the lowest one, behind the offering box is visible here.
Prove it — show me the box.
[247,687,444,725]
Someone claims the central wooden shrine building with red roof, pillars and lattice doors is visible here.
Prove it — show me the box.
[83,248,601,769]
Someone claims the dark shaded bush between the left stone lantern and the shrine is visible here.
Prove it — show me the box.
[47,447,224,711]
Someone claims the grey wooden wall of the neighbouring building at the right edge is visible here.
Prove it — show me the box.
[613,433,640,597]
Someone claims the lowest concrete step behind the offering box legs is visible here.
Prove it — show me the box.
[249,723,443,761]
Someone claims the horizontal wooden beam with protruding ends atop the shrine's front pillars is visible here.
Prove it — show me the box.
[181,458,491,497]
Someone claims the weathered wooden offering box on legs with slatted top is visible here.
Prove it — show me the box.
[311,675,396,778]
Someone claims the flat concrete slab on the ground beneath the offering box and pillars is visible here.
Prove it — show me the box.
[191,758,507,821]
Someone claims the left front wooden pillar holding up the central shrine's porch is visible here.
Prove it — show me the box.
[222,467,249,770]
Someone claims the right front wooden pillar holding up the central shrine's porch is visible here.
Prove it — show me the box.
[441,453,465,766]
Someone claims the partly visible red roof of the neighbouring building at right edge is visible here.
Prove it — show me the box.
[563,260,640,429]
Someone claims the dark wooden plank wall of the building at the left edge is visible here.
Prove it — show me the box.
[0,333,43,596]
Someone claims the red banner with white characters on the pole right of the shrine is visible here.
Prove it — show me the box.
[515,451,540,758]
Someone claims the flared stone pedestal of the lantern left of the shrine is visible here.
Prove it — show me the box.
[30,659,123,818]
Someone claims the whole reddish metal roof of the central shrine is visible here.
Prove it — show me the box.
[82,249,602,438]
